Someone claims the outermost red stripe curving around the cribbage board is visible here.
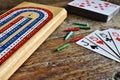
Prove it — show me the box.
[0,7,53,65]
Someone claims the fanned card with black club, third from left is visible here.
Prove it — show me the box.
[95,29,120,57]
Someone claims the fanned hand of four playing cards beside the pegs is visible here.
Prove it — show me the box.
[76,29,120,62]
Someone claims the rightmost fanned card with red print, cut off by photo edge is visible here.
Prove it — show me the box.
[108,29,120,56]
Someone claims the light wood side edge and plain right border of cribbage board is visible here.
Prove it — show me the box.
[0,2,67,80]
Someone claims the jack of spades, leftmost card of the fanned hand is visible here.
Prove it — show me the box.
[76,38,120,62]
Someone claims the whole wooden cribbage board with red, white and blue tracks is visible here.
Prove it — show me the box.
[0,2,67,80]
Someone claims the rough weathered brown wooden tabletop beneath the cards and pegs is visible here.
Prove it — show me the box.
[0,0,120,80]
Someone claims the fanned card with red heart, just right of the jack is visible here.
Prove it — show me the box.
[86,30,120,58]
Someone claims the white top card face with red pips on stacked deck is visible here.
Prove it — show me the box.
[69,0,120,15]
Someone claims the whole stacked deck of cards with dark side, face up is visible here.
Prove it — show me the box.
[68,0,120,22]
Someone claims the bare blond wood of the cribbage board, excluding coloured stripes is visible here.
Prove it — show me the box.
[0,2,67,80]
